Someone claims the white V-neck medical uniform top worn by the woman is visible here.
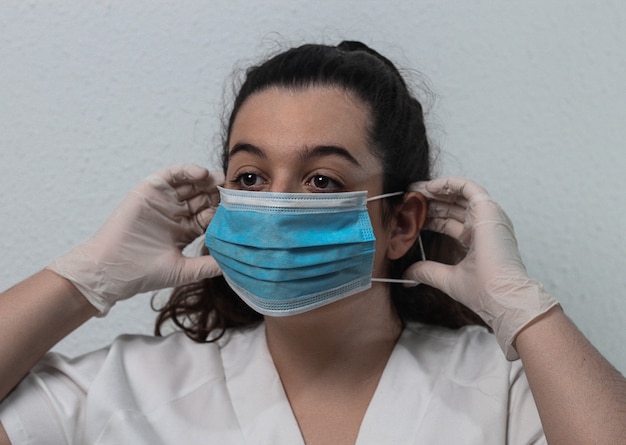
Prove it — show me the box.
[0,324,546,445]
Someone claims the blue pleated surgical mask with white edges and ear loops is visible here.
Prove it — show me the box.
[206,188,416,316]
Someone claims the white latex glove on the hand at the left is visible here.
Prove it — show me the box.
[48,164,224,315]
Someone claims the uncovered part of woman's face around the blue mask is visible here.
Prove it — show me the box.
[225,87,387,277]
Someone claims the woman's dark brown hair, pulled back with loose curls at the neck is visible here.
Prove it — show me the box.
[156,42,485,342]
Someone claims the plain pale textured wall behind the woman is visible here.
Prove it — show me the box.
[0,0,626,372]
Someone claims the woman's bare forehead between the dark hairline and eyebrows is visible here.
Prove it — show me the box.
[229,86,370,153]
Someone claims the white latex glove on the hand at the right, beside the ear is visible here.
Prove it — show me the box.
[404,178,558,360]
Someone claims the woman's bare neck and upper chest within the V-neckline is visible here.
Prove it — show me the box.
[265,283,402,444]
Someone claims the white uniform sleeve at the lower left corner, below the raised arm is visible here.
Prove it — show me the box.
[0,350,107,445]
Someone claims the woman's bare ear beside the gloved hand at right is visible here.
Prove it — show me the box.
[387,192,428,260]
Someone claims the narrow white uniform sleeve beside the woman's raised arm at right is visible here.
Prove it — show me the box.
[507,361,548,445]
